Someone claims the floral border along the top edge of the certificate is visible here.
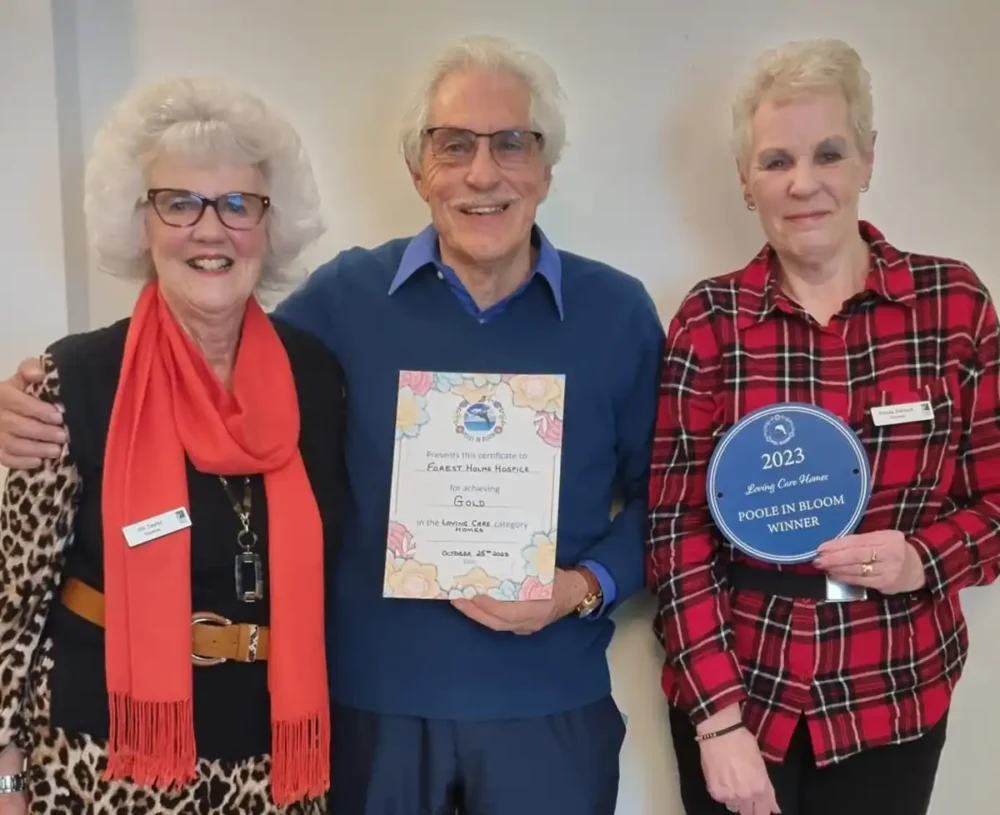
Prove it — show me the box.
[396,371,565,447]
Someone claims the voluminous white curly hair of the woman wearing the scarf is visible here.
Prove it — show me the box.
[84,78,323,288]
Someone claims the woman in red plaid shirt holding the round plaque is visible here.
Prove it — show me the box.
[650,36,1000,815]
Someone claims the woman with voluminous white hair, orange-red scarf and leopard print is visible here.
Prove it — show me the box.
[0,75,343,813]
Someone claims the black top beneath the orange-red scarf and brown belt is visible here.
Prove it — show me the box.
[47,320,346,760]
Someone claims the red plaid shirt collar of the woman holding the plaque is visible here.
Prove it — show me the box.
[736,221,916,329]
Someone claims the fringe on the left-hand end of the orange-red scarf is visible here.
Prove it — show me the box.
[105,693,197,789]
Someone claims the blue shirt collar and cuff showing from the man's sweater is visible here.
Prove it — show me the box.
[389,224,617,618]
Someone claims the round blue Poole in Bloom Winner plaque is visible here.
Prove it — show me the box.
[706,402,871,563]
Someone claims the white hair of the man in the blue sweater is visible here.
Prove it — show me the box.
[400,36,566,170]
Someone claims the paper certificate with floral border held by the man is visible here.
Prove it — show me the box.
[383,371,565,600]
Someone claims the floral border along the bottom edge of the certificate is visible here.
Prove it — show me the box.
[382,521,556,600]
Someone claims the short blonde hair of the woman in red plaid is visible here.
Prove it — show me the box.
[732,39,874,169]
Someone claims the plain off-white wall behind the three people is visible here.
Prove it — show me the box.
[0,0,1000,815]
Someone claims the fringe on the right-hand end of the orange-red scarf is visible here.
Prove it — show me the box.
[271,707,330,805]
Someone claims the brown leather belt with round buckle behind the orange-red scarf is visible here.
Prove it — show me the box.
[62,577,271,667]
